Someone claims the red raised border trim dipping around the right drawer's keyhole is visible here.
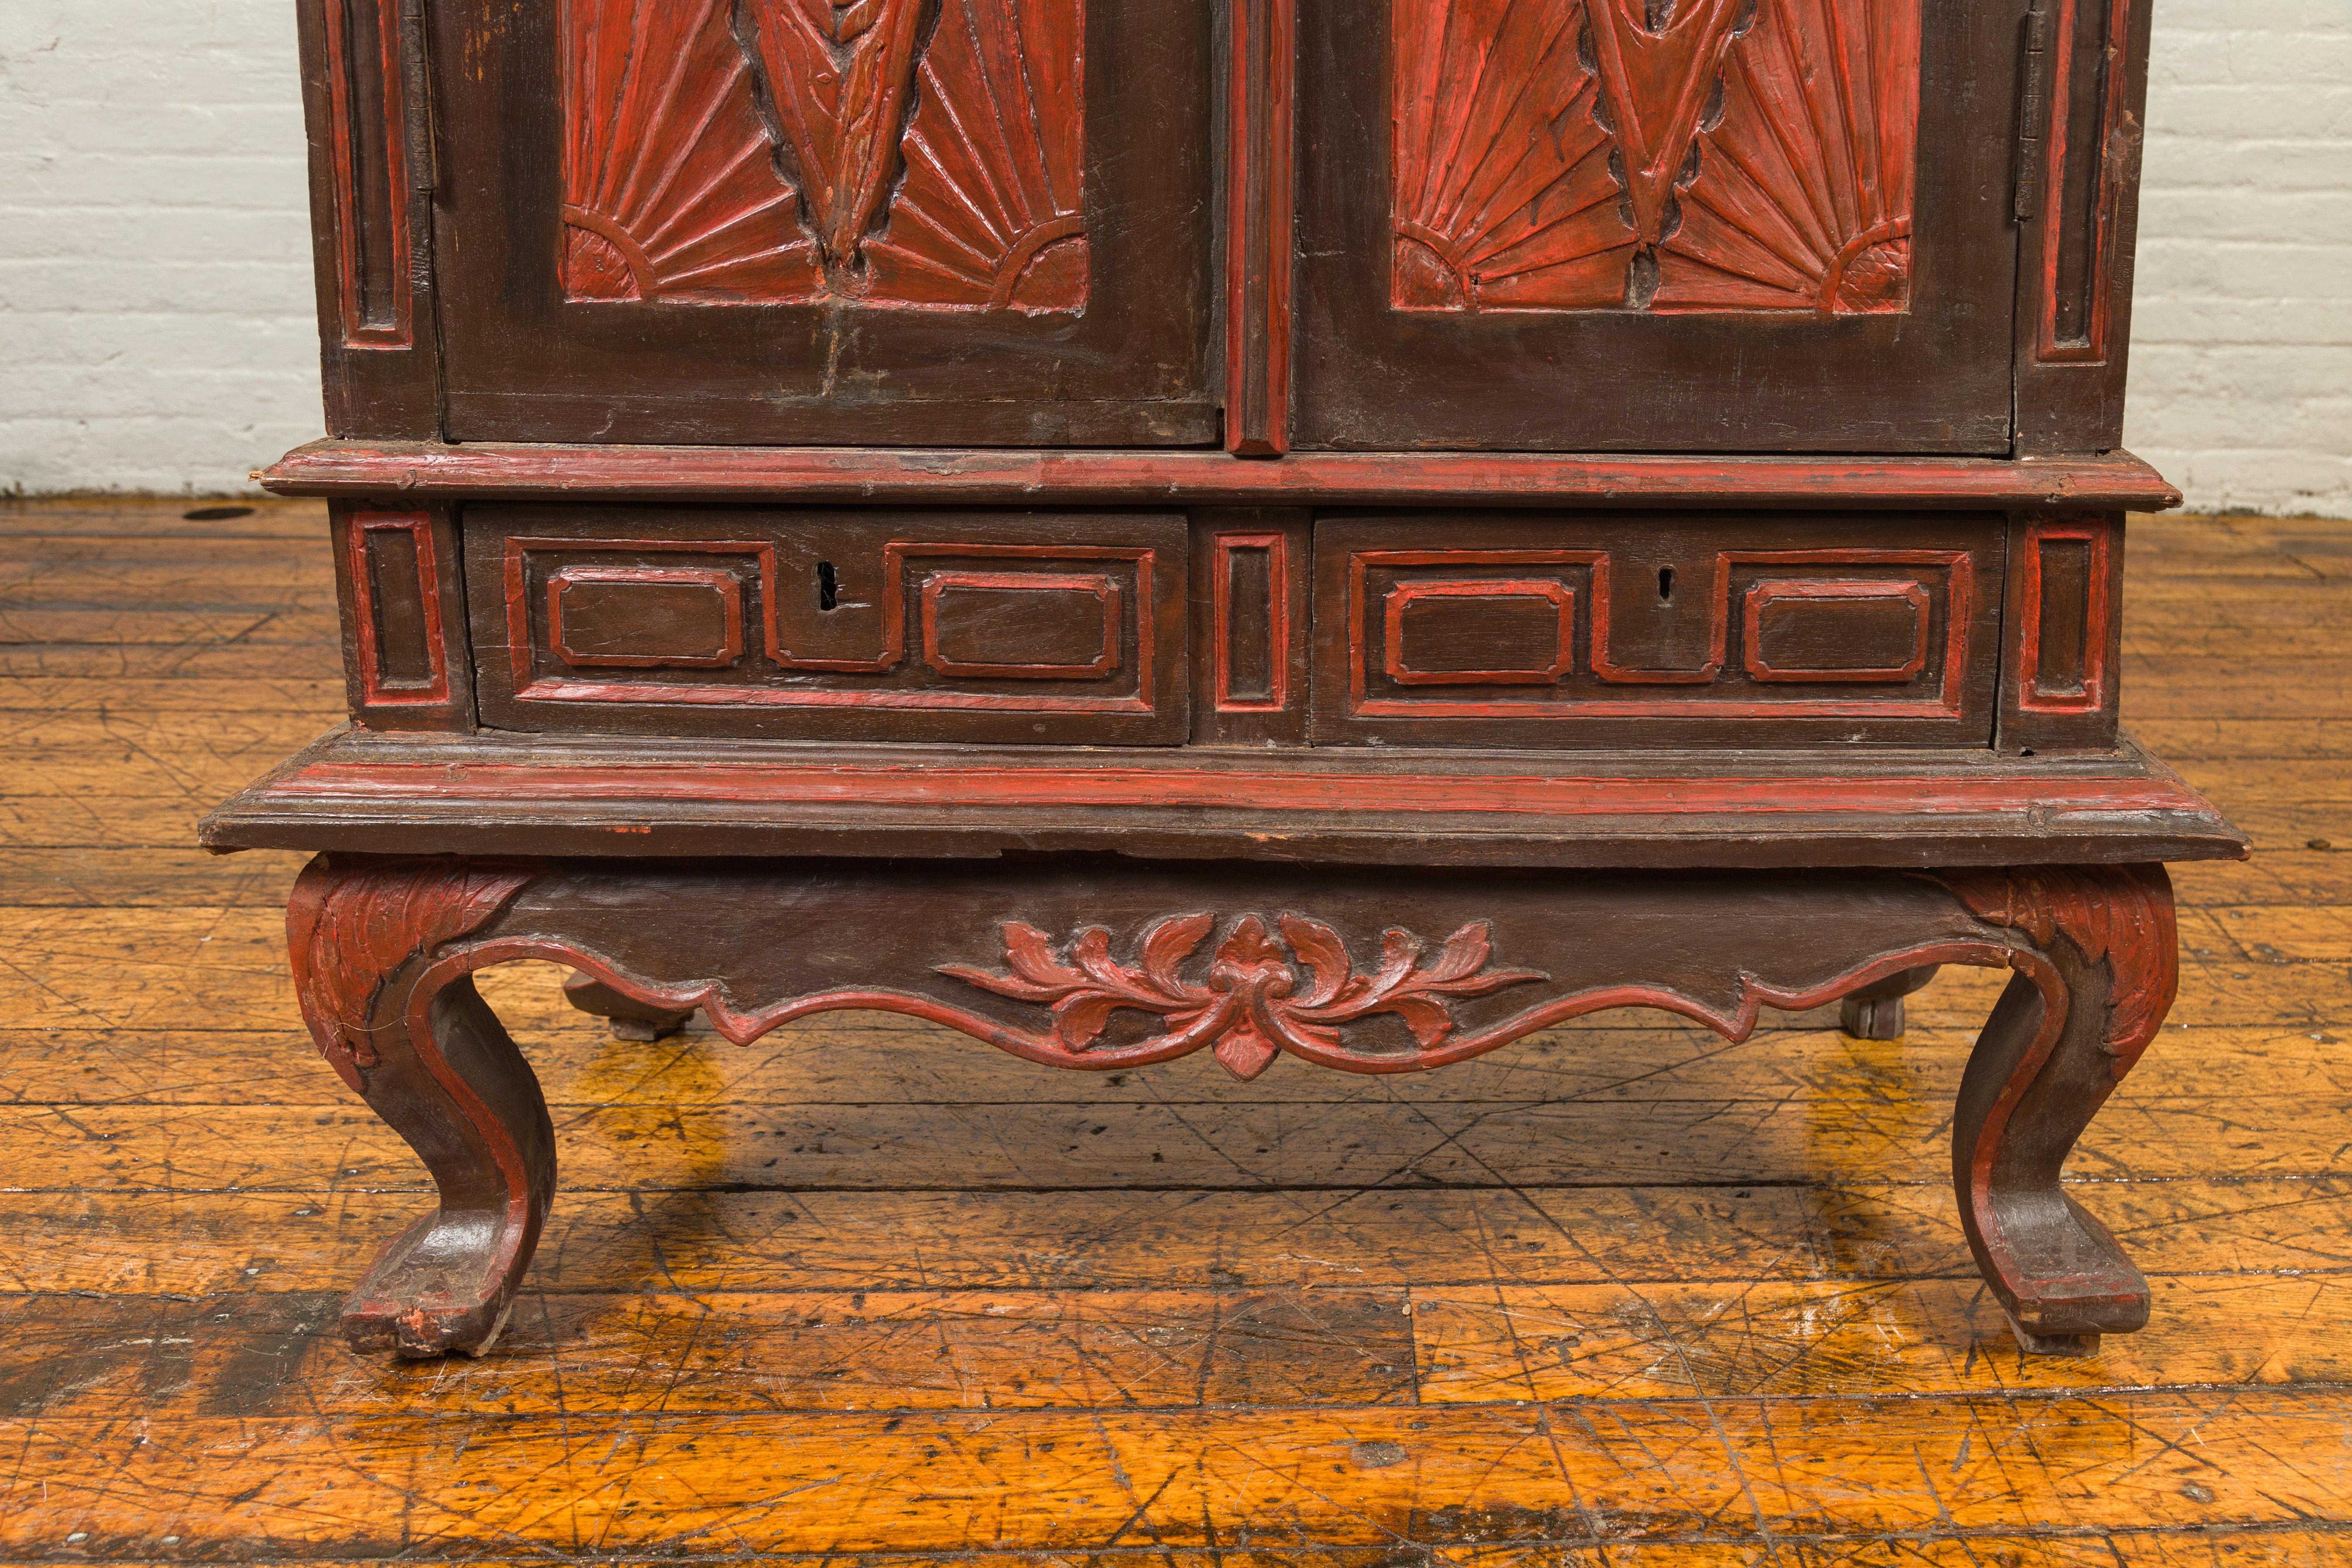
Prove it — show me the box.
[1348,550,1976,719]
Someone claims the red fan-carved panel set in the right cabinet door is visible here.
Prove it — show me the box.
[1390,0,1919,315]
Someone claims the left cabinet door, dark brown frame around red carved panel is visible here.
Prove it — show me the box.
[433,0,1216,446]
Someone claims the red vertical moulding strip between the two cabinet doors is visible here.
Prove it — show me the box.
[1226,0,1298,458]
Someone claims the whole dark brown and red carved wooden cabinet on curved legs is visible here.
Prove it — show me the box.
[221,0,2244,1354]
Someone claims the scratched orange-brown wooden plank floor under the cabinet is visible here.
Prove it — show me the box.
[0,503,2352,1568]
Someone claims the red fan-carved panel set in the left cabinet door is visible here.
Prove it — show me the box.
[560,0,1089,312]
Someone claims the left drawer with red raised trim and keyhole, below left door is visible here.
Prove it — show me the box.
[466,505,1185,745]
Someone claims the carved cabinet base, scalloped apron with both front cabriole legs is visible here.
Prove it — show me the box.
[287,853,2178,1356]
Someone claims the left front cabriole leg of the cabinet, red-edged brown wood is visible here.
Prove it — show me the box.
[287,856,555,1356]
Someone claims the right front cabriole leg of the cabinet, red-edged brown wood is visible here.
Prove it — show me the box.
[1950,868,2178,1354]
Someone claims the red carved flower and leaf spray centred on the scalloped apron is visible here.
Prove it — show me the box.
[941,914,1550,1079]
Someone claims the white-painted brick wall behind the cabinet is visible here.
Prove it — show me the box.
[0,0,2352,517]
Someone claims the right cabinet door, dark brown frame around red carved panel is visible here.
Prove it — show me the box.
[1298,0,2023,454]
